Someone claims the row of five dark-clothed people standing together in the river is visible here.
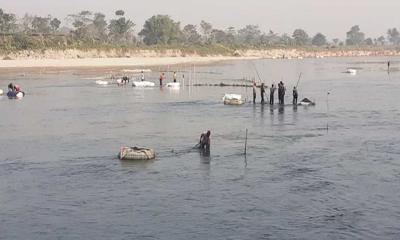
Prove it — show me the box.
[253,81,299,105]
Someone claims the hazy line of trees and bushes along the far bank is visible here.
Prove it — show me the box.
[0,9,400,50]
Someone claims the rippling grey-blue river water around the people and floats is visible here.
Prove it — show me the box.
[0,57,400,240]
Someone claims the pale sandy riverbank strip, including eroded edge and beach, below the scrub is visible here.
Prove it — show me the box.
[0,48,400,69]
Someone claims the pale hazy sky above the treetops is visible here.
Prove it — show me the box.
[0,0,400,39]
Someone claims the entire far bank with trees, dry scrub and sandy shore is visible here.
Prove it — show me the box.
[0,8,400,68]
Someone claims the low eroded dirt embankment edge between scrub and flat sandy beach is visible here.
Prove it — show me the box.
[0,48,400,60]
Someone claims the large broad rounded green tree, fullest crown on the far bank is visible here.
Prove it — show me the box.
[139,15,181,45]
